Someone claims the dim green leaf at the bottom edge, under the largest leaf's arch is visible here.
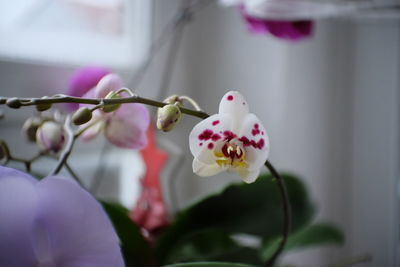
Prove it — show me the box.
[166,230,261,264]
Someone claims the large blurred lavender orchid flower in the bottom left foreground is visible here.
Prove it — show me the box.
[0,166,124,267]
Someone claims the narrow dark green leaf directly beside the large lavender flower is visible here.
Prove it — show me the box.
[101,202,152,267]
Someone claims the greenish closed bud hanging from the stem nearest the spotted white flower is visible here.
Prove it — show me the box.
[157,104,182,132]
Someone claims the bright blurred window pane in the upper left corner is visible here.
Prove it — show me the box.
[0,0,151,68]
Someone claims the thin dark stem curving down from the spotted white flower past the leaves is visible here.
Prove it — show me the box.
[264,160,292,267]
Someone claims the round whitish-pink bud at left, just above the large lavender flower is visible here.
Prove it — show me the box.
[36,121,65,153]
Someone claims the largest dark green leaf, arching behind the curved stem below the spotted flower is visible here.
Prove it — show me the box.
[156,175,314,263]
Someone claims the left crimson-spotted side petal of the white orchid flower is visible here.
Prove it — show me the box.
[189,114,232,157]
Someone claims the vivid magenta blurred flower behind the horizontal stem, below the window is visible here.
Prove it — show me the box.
[67,66,110,111]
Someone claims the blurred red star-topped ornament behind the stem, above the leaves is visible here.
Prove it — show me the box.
[130,126,169,238]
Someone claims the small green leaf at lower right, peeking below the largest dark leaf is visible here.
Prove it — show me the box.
[261,223,344,260]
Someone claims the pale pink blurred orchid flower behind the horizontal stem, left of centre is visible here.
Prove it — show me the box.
[81,73,150,149]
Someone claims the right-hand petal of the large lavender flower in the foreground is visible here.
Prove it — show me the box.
[37,177,123,267]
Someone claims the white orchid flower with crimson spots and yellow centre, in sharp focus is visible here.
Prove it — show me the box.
[189,91,269,183]
